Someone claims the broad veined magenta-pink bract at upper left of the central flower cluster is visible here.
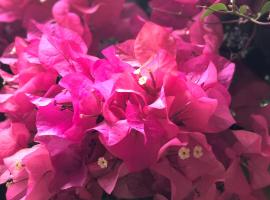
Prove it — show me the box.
[39,24,87,76]
